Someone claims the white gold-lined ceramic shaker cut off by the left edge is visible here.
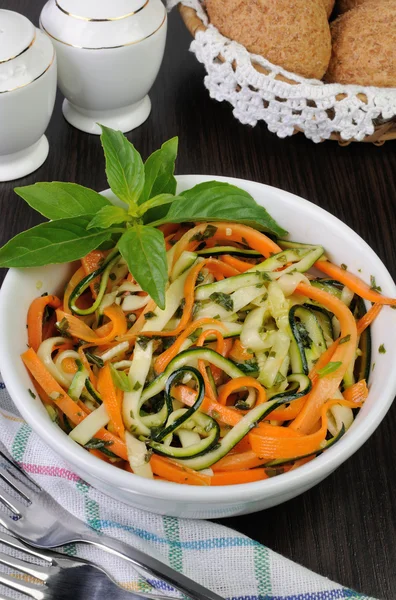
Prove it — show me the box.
[0,9,56,181]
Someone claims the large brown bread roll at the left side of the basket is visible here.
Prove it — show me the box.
[206,0,331,79]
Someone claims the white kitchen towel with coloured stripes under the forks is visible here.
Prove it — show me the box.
[0,381,373,600]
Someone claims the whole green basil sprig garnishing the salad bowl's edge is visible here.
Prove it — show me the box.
[0,125,287,309]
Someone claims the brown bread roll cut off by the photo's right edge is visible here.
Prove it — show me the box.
[325,0,396,87]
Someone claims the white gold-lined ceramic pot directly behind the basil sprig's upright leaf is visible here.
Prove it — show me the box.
[40,0,167,134]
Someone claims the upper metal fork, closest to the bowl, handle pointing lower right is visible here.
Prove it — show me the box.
[0,451,223,600]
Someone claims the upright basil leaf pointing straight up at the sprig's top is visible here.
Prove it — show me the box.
[100,125,144,206]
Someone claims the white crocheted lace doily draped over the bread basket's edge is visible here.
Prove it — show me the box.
[167,0,396,142]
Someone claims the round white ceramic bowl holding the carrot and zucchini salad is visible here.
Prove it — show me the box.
[0,175,396,518]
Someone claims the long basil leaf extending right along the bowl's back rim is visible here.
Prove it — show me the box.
[152,181,287,237]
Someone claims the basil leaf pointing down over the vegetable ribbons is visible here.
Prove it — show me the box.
[118,225,168,309]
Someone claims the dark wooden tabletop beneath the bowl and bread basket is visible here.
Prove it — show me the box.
[0,0,396,600]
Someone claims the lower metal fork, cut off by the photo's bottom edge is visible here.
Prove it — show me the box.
[0,533,177,600]
